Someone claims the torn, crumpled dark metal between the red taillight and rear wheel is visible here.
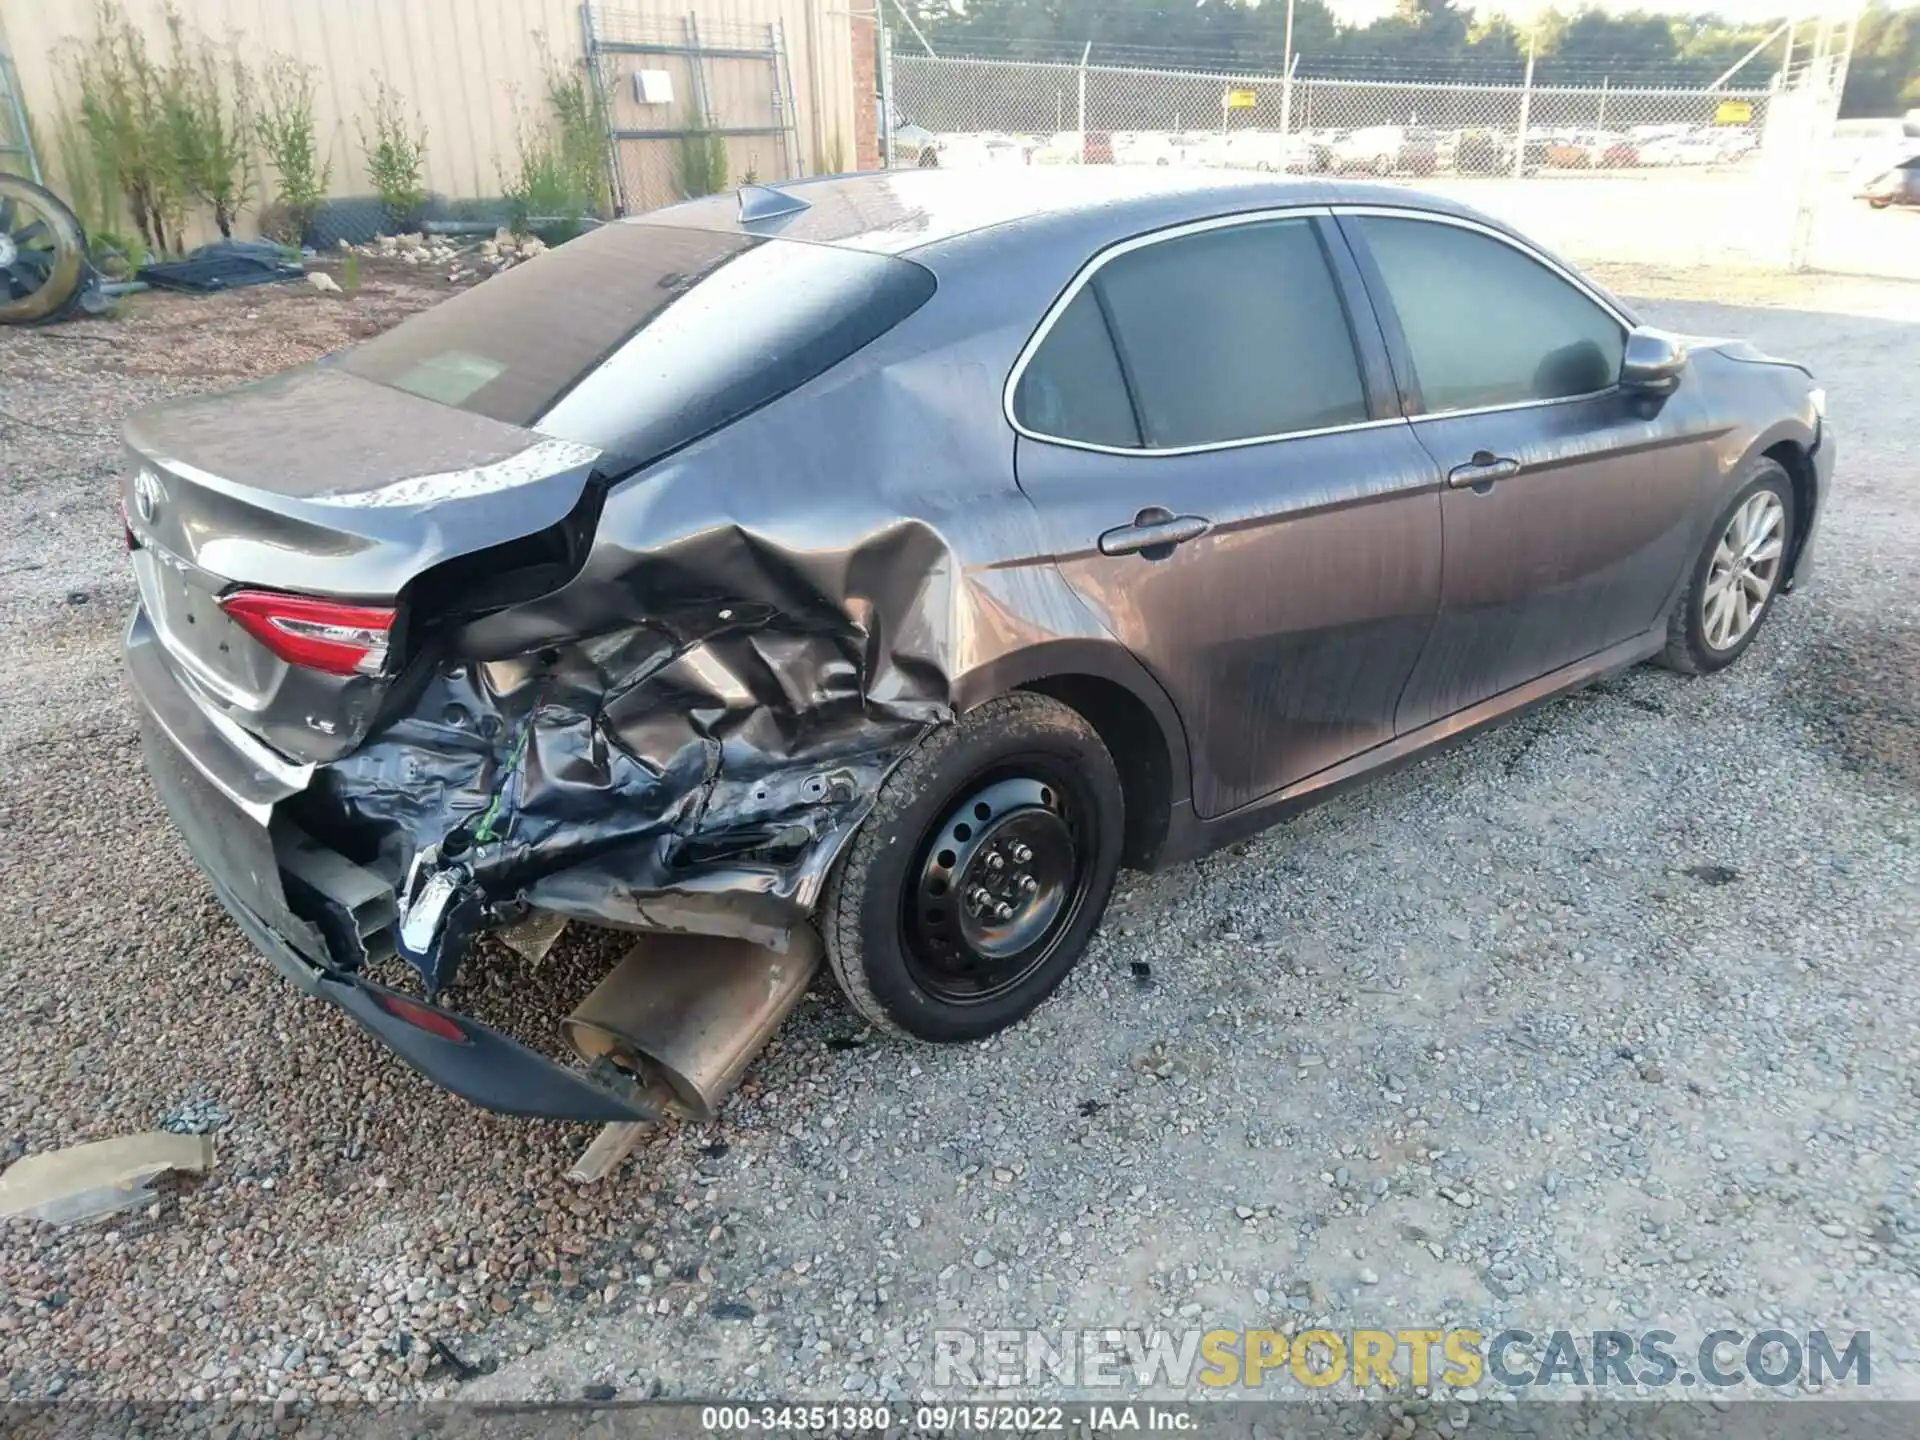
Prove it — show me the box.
[298,541,945,993]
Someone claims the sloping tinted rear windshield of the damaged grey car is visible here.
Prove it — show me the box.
[338,223,933,461]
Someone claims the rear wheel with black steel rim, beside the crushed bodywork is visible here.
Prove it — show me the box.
[820,693,1125,1041]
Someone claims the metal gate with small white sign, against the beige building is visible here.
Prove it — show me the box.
[582,4,801,215]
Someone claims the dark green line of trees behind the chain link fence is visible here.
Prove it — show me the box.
[899,0,1920,115]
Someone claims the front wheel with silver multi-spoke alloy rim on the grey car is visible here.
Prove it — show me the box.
[1661,457,1799,676]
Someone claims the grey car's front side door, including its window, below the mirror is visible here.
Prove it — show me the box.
[1340,209,1715,732]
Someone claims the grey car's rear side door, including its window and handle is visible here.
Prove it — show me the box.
[1010,211,1440,816]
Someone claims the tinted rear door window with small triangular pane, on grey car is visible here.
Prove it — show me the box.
[1016,219,1367,449]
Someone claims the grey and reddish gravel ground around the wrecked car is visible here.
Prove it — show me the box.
[0,259,1920,1400]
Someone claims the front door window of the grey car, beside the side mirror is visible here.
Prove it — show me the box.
[1348,215,1626,413]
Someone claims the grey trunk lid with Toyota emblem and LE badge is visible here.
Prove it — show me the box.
[121,365,599,762]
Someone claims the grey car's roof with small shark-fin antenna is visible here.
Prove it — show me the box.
[630,165,1471,255]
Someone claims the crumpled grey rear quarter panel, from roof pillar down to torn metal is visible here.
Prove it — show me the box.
[301,259,1110,975]
